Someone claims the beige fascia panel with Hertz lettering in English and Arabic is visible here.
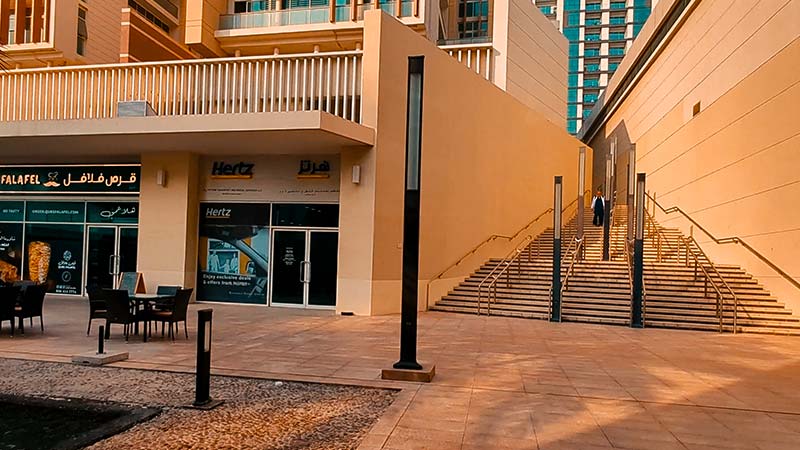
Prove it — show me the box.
[201,155,341,203]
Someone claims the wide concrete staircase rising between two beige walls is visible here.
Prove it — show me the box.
[432,205,800,335]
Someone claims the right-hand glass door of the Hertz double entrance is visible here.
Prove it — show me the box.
[307,231,339,308]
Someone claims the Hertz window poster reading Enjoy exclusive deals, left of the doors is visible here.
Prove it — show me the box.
[197,203,270,304]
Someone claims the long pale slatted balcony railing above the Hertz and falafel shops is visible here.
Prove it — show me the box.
[0,50,362,123]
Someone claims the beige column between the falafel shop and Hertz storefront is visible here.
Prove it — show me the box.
[138,152,200,292]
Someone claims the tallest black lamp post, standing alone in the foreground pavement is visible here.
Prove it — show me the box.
[393,56,425,370]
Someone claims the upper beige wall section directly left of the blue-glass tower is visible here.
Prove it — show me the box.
[492,0,569,127]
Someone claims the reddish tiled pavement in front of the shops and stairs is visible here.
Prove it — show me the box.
[0,298,800,450]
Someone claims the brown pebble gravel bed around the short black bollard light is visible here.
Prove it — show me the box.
[0,358,396,450]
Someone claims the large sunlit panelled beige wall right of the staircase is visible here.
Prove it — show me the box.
[591,0,800,311]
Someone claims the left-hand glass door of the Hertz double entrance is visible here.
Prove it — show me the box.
[271,230,308,306]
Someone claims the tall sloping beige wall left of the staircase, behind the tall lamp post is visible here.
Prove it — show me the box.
[346,12,580,314]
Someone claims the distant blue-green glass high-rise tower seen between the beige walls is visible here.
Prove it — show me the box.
[534,0,655,134]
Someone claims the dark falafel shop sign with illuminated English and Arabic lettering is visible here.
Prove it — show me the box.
[0,164,141,194]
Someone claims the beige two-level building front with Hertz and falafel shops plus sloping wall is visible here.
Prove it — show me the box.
[0,10,588,315]
